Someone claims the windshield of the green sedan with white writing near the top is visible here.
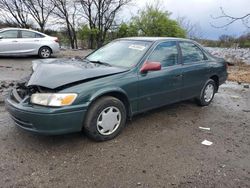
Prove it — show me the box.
[86,40,152,67]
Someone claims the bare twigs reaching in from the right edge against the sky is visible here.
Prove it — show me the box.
[211,7,250,28]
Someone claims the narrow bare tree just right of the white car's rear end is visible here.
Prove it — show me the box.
[51,0,78,49]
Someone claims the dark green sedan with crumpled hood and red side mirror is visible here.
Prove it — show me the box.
[5,37,227,141]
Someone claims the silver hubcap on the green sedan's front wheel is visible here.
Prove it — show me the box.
[97,106,121,135]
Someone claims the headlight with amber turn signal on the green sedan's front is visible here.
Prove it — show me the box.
[31,93,77,107]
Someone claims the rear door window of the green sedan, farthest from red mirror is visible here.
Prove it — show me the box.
[179,42,205,64]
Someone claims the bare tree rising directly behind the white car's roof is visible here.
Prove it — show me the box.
[20,0,55,32]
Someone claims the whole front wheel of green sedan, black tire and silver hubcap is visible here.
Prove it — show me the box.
[83,96,127,141]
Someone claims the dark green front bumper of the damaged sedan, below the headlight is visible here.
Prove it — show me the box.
[5,91,88,135]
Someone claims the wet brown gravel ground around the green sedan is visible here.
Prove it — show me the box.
[0,49,250,187]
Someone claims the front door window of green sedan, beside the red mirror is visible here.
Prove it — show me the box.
[148,41,178,67]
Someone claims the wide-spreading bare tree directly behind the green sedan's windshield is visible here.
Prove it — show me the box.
[78,0,132,48]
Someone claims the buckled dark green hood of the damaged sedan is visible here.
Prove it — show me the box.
[27,59,128,89]
